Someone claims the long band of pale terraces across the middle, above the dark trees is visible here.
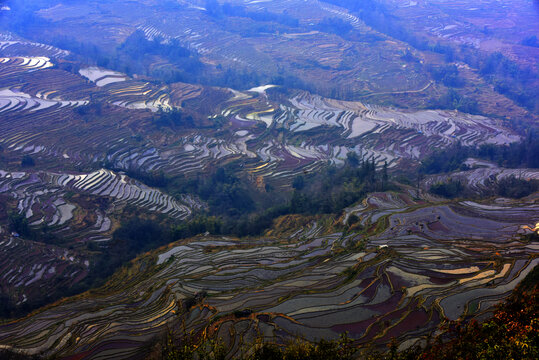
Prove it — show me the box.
[0,47,519,186]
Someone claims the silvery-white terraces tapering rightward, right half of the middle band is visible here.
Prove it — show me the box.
[222,88,518,183]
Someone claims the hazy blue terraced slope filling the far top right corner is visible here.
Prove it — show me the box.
[384,0,539,68]
